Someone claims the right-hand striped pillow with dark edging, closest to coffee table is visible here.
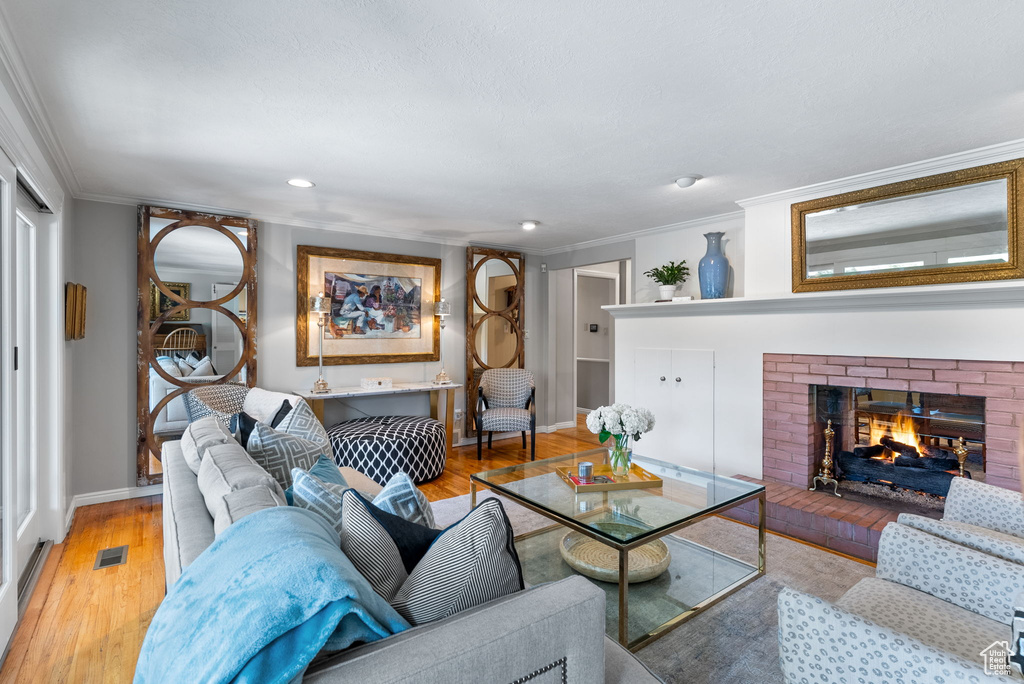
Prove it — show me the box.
[387,499,523,625]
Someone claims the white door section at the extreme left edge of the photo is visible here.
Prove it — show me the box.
[0,148,20,645]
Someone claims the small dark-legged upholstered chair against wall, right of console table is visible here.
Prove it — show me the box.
[476,369,537,461]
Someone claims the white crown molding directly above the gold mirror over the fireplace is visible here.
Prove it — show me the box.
[736,139,1024,209]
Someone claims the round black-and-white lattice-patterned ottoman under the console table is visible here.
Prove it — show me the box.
[327,416,445,484]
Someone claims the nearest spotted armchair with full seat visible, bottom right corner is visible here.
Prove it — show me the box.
[778,522,1024,684]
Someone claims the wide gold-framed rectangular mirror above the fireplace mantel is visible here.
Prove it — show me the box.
[792,159,1024,292]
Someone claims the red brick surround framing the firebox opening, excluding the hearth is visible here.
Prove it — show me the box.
[763,354,1024,493]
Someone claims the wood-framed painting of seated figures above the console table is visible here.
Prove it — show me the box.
[295,245,441,366]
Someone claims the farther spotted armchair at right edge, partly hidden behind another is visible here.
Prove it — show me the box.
[899,477,1024,565]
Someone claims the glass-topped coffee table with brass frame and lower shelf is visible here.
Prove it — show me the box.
[470,448,765,650]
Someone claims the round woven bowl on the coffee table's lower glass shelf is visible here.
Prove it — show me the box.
[558,522,672,584]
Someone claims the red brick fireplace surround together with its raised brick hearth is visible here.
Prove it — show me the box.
[728,354,1024,561]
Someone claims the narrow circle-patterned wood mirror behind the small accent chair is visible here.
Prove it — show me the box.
[466,247,526,436]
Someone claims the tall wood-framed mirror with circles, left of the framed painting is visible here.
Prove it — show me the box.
[136,206,257,486]
